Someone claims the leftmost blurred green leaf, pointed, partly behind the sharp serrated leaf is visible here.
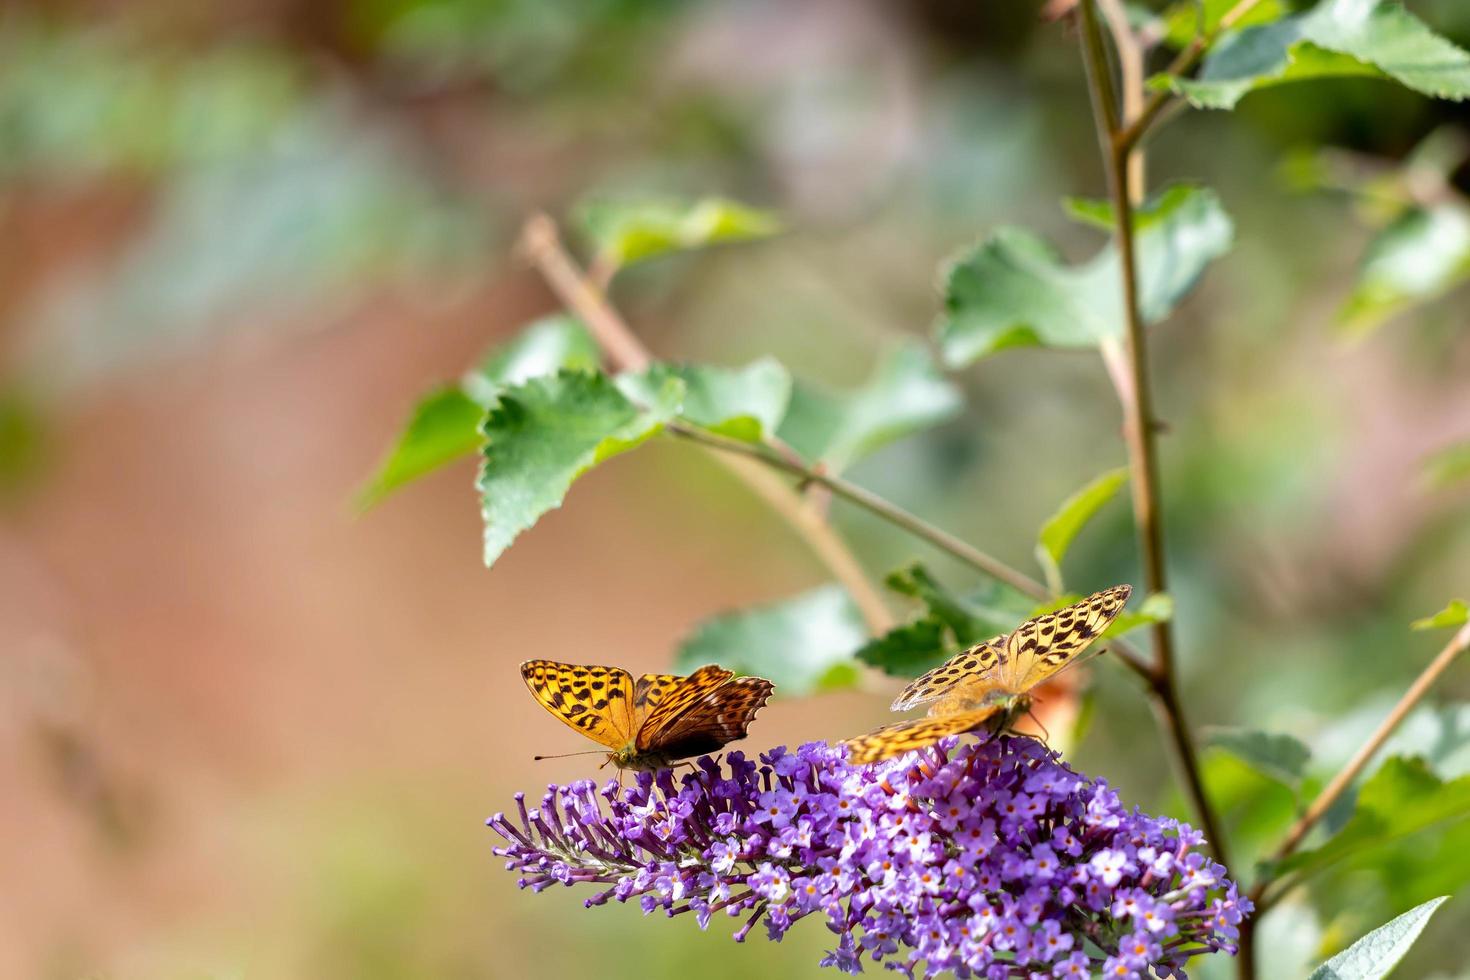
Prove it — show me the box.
[357,316,600,508]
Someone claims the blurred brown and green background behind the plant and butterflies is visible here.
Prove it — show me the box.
[0,0,1470,980]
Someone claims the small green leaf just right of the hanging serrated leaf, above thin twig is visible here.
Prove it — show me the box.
[619,357,791,442]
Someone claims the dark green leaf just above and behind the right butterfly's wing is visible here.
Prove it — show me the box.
[857,563,1026,677]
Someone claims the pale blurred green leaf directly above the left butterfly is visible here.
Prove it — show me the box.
[675,585,867,698]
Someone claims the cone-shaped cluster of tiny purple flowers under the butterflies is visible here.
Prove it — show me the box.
[490,738,1251,980]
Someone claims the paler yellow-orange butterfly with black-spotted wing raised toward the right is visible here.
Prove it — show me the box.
[844,585,1133,764]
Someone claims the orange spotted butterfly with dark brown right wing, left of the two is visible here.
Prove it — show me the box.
[520,660,775,771]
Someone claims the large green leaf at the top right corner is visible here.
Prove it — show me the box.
[1151,0,1470,109]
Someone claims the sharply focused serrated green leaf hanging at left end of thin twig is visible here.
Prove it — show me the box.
[479,370,684,566]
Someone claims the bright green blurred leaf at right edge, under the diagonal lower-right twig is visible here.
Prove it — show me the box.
[1274,755,1470,877]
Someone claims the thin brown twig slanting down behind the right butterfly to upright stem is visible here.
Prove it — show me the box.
[666,422,1152,685]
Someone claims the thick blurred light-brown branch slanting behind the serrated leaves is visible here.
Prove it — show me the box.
[520,215,894,636]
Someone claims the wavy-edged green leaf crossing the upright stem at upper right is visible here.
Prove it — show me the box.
[938,184,1235,367]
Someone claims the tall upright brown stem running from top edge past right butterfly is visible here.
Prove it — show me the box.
[1079,0,1230,867]
